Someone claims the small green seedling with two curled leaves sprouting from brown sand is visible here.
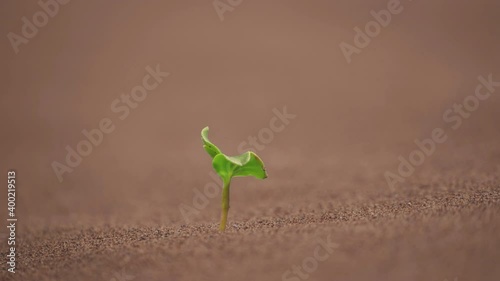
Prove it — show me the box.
[201,127,267,231]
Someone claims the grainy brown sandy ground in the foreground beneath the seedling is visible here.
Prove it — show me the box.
[3,168,500,280]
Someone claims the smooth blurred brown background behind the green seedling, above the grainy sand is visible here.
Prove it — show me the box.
[0,0,500,278]
